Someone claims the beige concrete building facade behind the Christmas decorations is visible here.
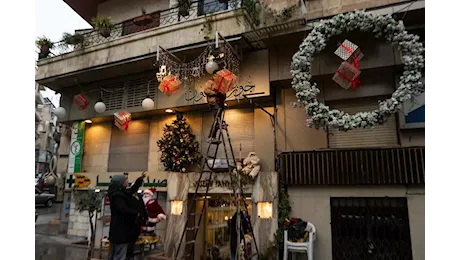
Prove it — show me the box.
[36,0,426,260]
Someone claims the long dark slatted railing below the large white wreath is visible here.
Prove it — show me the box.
[278,147,425,185]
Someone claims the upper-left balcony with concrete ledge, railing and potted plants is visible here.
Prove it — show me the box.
[36,0,252,88]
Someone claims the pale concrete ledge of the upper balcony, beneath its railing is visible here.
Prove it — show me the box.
[36,10,250,90]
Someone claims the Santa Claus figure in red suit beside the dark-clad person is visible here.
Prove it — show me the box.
[142,188,166,233]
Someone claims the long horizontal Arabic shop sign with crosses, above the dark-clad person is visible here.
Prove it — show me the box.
[65,172,167,191]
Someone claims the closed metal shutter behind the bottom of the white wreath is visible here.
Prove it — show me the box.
[329,100,399,148]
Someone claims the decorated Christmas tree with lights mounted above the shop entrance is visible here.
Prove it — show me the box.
[157,114,202,172]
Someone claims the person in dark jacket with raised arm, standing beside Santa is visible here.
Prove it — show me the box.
[108,174,145,260]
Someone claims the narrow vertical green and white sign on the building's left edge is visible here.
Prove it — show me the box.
[67,121,85,174]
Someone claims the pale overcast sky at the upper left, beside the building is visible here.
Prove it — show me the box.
[32,0,91,107]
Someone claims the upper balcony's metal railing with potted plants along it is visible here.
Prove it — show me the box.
[43,0,246,59]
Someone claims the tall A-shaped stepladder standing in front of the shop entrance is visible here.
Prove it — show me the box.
[174,107,259,260]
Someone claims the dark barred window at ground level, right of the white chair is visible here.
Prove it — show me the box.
[331,198,412,260]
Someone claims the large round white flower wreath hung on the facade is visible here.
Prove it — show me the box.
[291,11,424,131]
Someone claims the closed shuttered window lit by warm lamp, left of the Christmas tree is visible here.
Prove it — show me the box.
[107,120,150,172]
